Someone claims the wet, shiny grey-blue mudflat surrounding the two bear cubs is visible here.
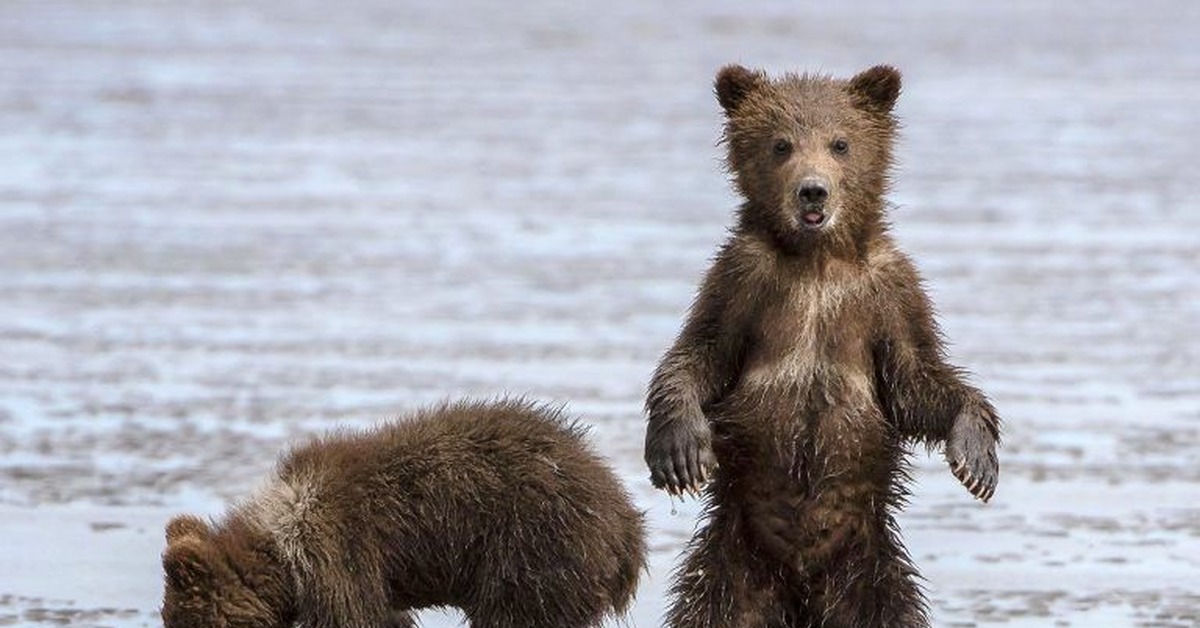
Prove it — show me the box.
[0,0,1200,627]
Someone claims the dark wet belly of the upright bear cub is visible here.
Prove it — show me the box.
[712,375,900,573]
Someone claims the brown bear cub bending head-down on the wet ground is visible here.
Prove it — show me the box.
[162,401,646,628]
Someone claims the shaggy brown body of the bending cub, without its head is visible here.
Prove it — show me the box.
[238,401,644,612]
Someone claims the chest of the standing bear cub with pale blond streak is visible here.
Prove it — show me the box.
[724,270,887,476]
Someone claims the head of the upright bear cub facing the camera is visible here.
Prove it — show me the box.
[716,65,900,250]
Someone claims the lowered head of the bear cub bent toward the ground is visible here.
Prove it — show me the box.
[162,515,292,628]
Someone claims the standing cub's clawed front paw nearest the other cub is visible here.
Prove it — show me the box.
[646,419,716,495]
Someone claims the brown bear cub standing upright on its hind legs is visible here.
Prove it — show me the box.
[646,66,1000,628]
